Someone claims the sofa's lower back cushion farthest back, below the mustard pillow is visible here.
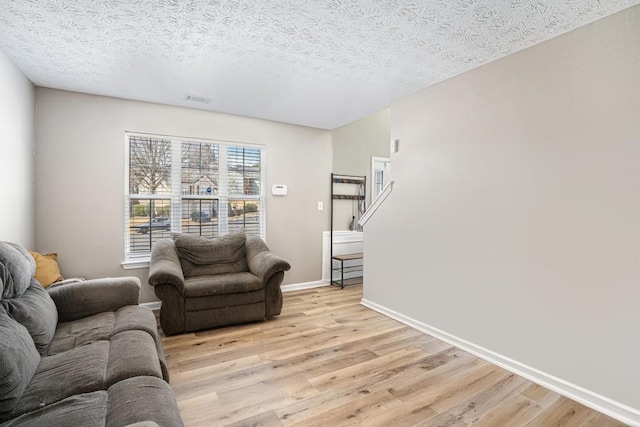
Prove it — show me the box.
[0,279,58,356]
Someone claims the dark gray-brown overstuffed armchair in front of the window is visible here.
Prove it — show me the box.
[149,230,291,335]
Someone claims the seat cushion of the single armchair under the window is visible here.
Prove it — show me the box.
[184,272,264,298]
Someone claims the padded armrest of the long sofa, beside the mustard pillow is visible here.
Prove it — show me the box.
[47,277,140,322]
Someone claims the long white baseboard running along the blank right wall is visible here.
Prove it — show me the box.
[361,298,640,426]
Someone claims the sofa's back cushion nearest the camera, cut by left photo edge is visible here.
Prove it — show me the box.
[0,308,40,422]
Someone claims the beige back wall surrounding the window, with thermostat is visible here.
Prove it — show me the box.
[36,88,331,302]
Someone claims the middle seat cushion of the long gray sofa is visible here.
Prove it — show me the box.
[12,330,162,416]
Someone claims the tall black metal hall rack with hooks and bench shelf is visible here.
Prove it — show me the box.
[329,173,367,289]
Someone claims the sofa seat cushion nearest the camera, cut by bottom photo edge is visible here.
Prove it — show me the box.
[0,377,183,427]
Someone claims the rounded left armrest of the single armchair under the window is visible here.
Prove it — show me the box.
[149,239,184,294]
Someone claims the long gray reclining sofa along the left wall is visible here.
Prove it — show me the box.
[0,242,183,427]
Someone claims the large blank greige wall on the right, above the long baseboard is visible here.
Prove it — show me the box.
[364,6,640,423]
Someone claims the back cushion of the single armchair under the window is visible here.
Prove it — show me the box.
[171,230,248,278]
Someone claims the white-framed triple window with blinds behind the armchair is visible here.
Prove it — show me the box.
[125,133,265,260]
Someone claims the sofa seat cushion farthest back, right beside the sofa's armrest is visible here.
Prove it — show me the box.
[48,305,157,355]
